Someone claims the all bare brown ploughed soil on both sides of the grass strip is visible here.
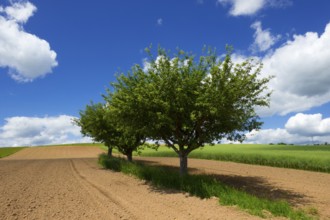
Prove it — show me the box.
[0,146,330,219]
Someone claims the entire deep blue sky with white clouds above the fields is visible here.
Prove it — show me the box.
[0,0,330,147]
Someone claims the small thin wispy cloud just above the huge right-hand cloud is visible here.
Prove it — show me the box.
[251,21,280,52]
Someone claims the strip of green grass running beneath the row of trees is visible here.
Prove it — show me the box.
[98,154,312,220]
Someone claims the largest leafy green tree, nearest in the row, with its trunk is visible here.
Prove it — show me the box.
[105,49,270,174]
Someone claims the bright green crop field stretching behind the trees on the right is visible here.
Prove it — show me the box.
[136,144,330,173]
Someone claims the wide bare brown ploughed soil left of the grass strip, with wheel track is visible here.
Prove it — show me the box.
[0,147,258,219]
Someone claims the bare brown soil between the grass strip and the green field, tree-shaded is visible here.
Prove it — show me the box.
[137,157,330,220]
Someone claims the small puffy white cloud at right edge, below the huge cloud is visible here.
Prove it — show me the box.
[285,113,330,137]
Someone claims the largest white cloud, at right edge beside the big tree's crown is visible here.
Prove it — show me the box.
[260,23,330,115]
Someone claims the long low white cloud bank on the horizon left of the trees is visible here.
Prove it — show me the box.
[0,115,91,146]
